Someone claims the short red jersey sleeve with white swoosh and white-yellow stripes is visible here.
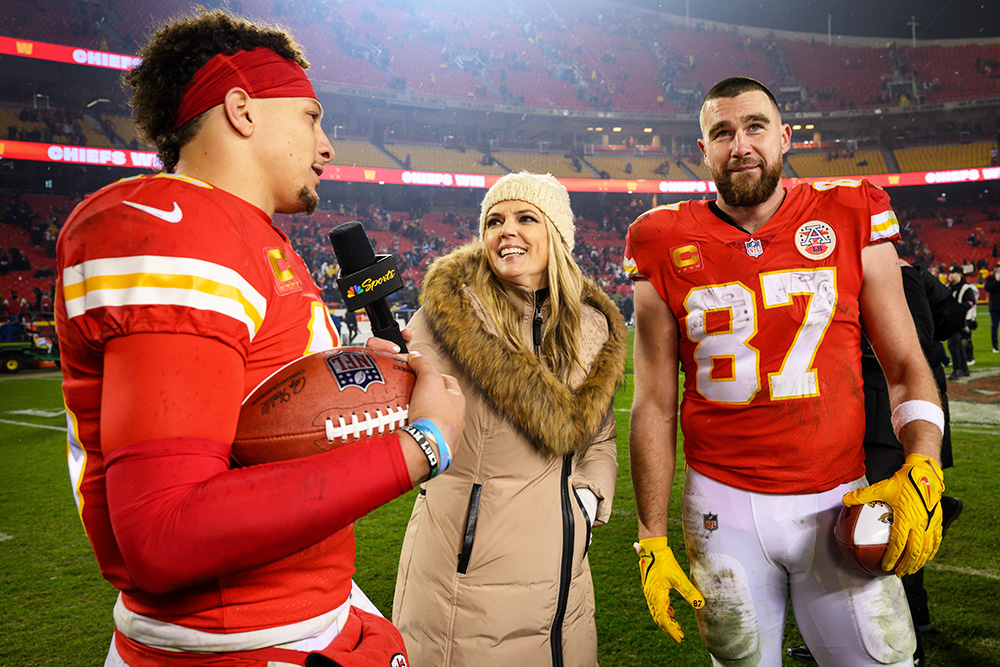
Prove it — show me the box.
[58,177,277,356]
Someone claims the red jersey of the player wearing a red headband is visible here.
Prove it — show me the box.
[56,174,354,632]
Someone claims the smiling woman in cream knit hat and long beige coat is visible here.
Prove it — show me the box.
[393,172,625,667]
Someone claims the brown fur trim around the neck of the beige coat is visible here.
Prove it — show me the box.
[423,243,627,456]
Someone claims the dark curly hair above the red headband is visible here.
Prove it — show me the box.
[123,7,309,173]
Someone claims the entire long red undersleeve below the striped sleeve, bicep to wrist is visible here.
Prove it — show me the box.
[101,334,412,593]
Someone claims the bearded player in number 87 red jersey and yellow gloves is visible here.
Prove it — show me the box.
[625,78,944,666]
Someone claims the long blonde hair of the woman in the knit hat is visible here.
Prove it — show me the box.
[473,215,585,382]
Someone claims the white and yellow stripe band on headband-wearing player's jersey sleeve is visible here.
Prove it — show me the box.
[63,255,267,340]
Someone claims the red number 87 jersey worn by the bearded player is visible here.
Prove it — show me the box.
[625,180,899,494]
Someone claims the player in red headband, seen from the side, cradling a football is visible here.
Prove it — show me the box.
[56,10,464,667]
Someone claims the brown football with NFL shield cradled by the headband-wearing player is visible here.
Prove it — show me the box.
[232,347,416,466]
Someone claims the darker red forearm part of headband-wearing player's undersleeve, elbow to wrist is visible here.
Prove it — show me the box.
[105,435,411,594]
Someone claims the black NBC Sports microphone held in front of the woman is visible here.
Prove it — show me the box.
[330,220,407,352]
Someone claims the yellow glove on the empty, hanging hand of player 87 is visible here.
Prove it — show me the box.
[635,537,705,643]
